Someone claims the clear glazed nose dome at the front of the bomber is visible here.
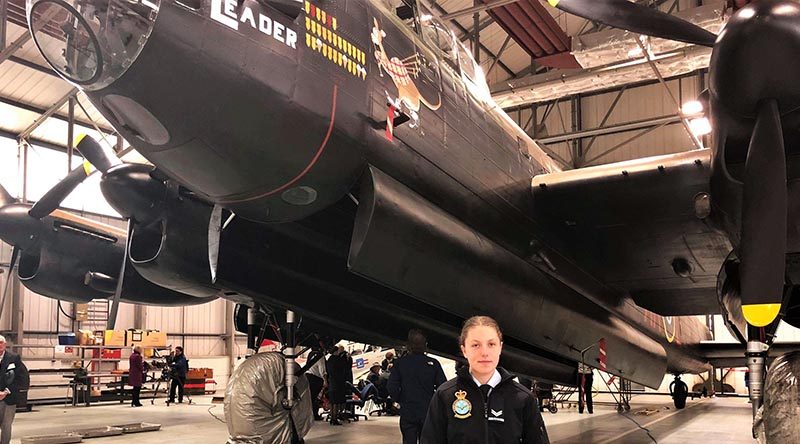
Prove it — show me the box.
[26,0,161,90]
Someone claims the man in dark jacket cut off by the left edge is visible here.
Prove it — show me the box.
[0,336,30,444]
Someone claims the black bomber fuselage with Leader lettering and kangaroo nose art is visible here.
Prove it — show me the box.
[23,0,710,387]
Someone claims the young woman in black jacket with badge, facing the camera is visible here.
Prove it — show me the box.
[420,316,550,444]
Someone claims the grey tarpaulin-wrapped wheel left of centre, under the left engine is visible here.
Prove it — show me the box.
[225,352,314,444]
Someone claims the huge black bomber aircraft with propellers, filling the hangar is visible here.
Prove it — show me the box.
[10,0,800,424]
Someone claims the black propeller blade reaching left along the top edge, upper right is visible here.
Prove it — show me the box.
[548,0,717,47]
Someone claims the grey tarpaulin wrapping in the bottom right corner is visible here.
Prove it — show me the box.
[754,351,800,444]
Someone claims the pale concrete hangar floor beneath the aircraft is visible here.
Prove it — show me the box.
[12,395,755,444]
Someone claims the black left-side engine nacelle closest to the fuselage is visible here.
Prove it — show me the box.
[130,197,221,297]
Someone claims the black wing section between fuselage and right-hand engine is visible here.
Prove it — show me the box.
[532,149,732,316]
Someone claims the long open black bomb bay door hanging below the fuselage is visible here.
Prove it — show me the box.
[348,168,667,387]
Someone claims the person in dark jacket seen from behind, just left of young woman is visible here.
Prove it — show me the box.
[388,329,446,444]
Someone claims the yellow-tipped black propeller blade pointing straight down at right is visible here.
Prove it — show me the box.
[740,100,787,327]
